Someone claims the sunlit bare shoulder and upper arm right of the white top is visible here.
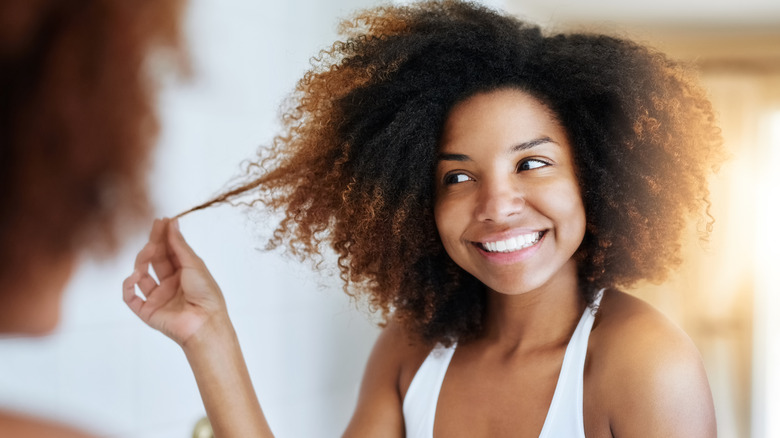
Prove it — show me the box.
[588,291,716,437]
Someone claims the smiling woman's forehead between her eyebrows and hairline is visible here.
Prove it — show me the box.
[439,88,567,151]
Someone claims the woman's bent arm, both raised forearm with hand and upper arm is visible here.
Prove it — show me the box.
[123,219,412,438]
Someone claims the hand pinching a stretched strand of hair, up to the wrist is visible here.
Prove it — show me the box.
[122,219,225,347]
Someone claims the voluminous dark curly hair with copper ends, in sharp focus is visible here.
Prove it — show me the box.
[189,1,721,344]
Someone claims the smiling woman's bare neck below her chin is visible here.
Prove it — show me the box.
[482,260,585,350]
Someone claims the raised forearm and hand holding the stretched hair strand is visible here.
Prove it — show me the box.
[123,219,273,438]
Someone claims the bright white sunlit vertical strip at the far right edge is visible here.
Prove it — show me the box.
[753,110,780,437]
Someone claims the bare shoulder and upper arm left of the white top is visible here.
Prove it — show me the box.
[344,322,427,437]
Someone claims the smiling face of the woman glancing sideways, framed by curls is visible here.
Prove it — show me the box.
[434,89,585,294]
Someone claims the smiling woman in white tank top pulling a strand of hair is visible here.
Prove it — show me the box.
[123,1,721,438]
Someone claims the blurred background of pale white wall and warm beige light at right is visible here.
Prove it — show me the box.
[0,0,780,438]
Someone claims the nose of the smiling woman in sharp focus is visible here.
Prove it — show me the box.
[475,178,525,223]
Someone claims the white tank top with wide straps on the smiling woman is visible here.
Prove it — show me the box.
[403,289,604,438]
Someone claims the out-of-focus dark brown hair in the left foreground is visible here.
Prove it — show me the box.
[0,0,187,283]
